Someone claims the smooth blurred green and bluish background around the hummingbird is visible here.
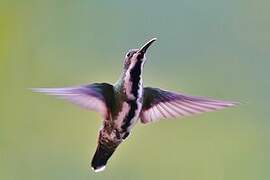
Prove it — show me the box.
[0,0,270,180]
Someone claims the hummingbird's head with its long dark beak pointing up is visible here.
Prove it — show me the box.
[124,38,156,70]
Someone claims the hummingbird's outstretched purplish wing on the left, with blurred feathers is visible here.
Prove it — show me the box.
[32,83,114,118]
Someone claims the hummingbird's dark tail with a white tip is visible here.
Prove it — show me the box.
[91,142,118,172]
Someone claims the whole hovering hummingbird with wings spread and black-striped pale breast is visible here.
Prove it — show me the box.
[33,38,237,172]
